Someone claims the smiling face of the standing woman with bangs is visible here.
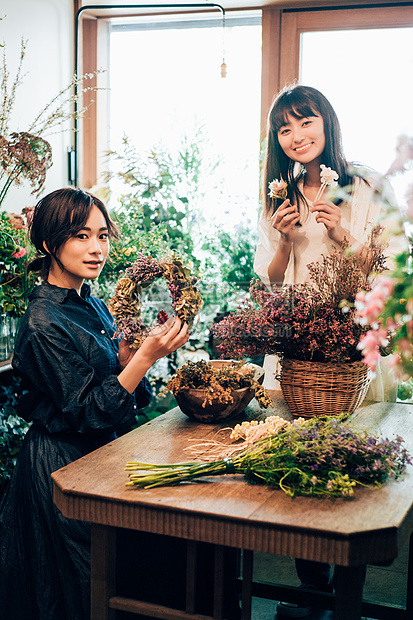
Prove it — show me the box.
[277,114,325,165]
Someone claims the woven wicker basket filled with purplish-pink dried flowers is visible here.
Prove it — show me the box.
[214,227,384,417]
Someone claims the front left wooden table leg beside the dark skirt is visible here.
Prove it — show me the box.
[90,524,116,620]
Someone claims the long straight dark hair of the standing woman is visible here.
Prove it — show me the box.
[262,84,353,215]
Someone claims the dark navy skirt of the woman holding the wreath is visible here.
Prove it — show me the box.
[0,425,107,620]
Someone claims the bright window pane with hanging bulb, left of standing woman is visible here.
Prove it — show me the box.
[110,13,261,228]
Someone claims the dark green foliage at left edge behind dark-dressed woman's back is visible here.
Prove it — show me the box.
[0,375,30,492]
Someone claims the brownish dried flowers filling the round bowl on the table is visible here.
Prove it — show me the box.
[165,360,272,409]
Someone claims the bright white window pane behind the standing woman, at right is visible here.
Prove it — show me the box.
[300,28,413,201]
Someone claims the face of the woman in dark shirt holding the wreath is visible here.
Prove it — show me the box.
[48,205,109,292]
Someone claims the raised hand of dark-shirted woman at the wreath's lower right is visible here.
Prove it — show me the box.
[139,317,189,364]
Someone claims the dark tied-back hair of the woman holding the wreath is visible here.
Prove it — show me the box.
[28,187,120,280]
